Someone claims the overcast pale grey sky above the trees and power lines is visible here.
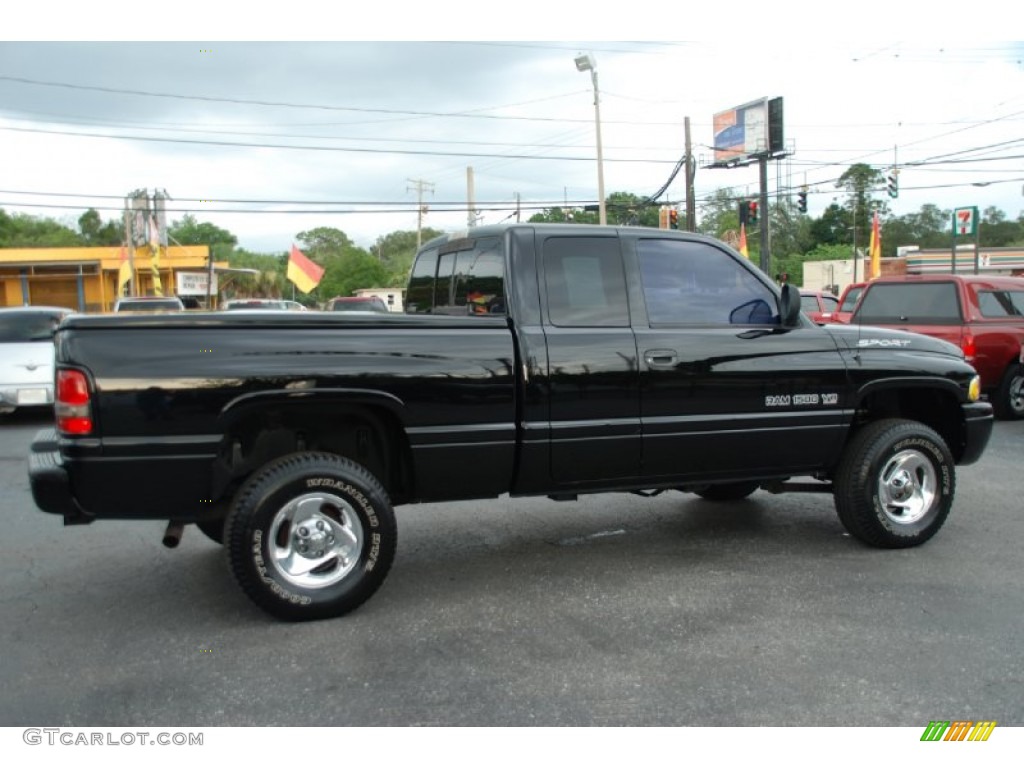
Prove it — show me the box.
[0,3,1024,252]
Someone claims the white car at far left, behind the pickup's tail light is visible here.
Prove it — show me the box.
[0,306,74,414]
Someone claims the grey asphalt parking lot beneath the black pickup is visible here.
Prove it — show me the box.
[0,415,1024,729]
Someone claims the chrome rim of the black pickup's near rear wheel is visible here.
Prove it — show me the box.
[267,494,364,589]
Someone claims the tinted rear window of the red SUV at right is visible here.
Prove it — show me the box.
[854,282,962,326]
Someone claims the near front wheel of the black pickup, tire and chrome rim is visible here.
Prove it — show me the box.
[835,419,956,549]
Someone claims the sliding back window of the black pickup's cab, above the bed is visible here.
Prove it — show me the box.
[406,237,505,314]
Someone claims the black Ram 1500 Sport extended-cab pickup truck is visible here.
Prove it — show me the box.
[29,224,992,620]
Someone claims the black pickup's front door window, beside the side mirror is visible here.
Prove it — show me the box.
[637,239,774,326]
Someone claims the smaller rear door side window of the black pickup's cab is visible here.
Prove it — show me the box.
[544,237,630,328]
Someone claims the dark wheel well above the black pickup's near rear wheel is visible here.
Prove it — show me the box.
[214,402,413,504]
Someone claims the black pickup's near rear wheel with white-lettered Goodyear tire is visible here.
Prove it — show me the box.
[225,453,397,621]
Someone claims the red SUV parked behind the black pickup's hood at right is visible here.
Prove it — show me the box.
[850,274,1024,419]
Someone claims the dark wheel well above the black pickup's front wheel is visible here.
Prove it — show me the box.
[853,387,967,461]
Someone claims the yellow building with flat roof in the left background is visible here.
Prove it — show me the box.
[0,246,210,312]
